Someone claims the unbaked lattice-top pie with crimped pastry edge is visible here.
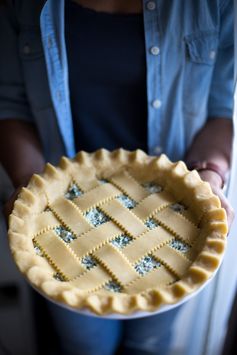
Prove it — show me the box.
[9,149,227,315]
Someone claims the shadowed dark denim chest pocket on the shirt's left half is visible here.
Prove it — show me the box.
[18,29,52,111]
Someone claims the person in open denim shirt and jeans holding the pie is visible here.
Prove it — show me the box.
[0,0,234,355]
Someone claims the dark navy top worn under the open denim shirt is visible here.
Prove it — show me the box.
[65,1,147,151]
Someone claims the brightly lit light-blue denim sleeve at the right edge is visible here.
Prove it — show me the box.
[208,0,234,119]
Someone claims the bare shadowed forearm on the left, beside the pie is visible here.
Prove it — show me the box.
[0,119,44,187]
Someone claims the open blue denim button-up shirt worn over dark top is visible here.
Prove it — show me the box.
[0,0,234,162]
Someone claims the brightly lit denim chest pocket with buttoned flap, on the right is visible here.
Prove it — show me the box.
[183,31,218,117]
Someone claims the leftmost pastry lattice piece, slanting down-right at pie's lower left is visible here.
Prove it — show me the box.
[34,231,85,279]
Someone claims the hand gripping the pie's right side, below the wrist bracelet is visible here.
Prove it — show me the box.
[199,170,234,230]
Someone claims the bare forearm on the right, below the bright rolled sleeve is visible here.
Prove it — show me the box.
[185,118,233,188]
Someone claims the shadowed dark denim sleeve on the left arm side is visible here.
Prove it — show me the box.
[0,5,33,122]
